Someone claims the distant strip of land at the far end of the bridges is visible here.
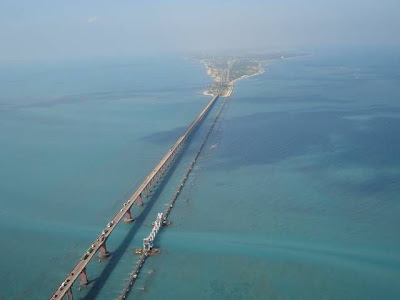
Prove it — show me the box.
[188,52,308,97]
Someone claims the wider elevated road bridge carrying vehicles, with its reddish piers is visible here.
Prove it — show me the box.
[50,95,219,299]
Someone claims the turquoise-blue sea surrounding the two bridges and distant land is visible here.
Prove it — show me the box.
[0,47,400,300]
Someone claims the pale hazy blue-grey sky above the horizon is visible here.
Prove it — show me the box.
[0,0,400,61]
